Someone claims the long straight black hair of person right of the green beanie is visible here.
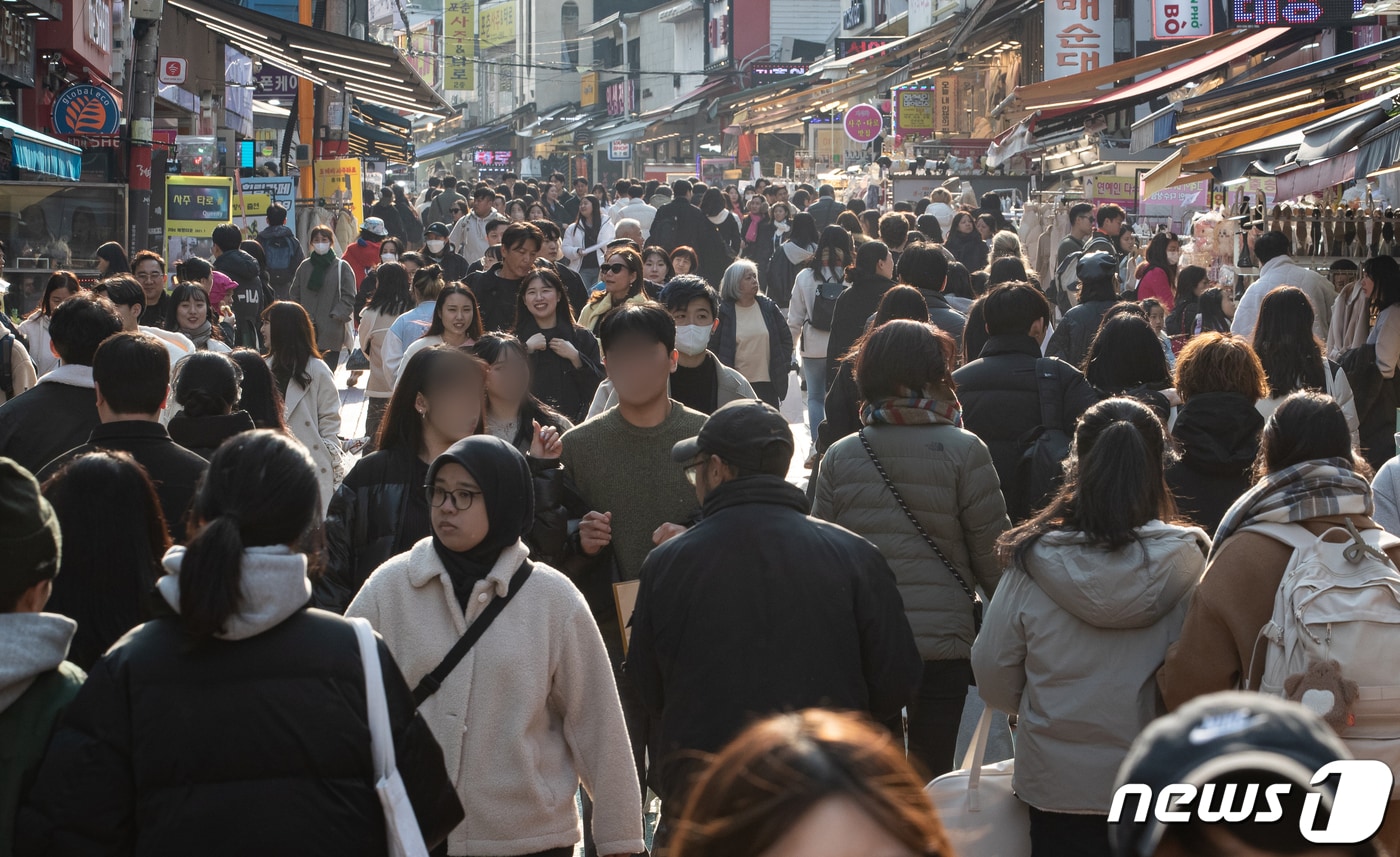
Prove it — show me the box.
[43,450,170,671]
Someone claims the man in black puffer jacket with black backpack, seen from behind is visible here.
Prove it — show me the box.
[953,283,1099,522]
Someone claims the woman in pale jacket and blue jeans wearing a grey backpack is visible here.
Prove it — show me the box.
[783,225,855,442]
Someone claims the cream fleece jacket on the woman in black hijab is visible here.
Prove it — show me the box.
[346,538,644,857]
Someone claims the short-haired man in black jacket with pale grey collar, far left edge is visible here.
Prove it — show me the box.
[0,292,121,467]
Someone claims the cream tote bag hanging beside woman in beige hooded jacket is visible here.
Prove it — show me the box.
[924,707,1030,857]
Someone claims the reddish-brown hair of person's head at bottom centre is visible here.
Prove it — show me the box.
[671,710,952,857]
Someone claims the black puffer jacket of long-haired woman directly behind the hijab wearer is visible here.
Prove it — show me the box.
[320,450,568,613]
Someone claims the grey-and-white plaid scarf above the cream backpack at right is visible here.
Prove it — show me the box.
[1211,458,1375,553]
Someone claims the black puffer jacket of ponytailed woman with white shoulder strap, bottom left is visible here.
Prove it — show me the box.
[15,611,463,857]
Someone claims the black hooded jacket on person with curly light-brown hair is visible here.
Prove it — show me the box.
[1166,393,1264,532]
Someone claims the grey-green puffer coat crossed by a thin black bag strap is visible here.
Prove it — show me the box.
[812,424,1011,661]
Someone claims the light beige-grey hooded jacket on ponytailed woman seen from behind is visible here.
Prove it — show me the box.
[972,521,1210,814]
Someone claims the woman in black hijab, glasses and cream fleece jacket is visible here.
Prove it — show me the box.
[347,436,644,856]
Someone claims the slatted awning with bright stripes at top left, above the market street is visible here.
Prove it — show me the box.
[169,0,452,116]
